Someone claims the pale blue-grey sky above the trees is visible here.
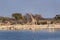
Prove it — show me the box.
[0,0,60,18]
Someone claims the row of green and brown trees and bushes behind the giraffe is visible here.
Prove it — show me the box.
[0,13,60,23]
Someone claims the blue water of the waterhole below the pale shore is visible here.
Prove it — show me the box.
[0,30,60,40]
